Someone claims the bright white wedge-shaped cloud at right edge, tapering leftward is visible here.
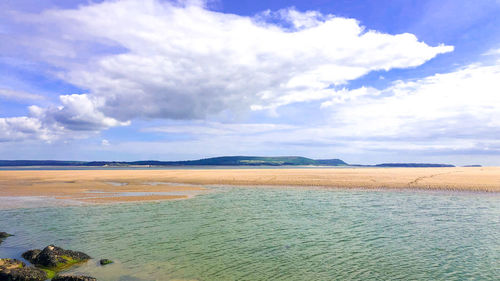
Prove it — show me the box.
[323,62,500,140]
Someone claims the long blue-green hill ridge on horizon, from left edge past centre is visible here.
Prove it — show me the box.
[0,156,348,167]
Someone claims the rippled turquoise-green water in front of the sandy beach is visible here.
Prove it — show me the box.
[0,188,500,281]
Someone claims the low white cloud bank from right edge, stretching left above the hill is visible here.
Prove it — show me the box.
[140,59,500,158]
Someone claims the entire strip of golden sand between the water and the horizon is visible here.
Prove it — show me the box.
[0,167,500,206]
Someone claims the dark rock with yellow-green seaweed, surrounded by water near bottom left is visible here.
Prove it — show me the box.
[23,245,90,269]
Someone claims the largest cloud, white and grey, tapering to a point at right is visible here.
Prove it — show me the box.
[4,0,453,124]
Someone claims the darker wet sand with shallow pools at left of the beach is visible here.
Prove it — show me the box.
[0,170,208,205]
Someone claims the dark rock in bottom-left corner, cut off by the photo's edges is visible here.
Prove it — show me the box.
[0,259,48,281]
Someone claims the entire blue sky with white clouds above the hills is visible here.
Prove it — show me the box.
[0,0,500,166]
